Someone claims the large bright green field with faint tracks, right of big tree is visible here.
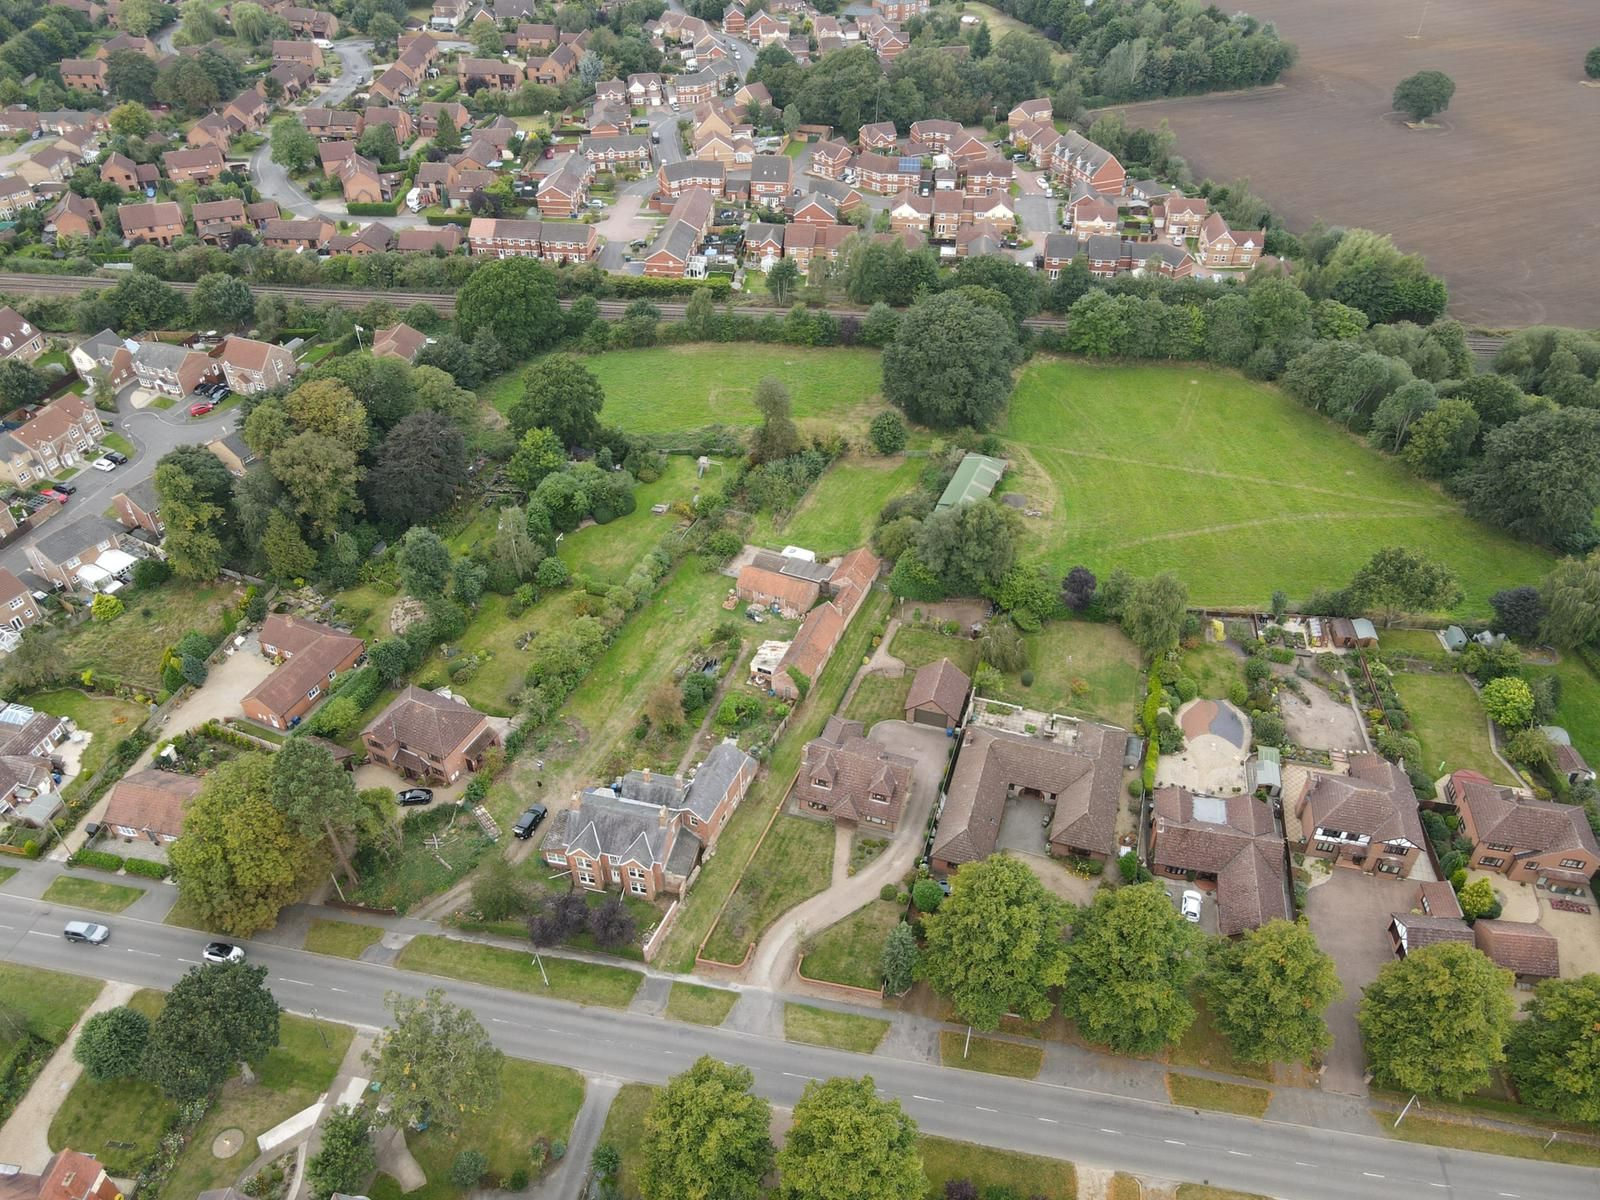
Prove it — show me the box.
[1002,357,1550,614]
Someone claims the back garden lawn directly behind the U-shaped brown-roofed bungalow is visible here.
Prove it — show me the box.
[992,621,1144,730]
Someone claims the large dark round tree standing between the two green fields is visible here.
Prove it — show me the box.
[883,291,1021,429]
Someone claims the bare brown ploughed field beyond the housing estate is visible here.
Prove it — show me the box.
[1125,0,1600,328]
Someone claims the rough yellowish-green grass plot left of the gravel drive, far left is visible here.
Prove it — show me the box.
[61,579,234,693]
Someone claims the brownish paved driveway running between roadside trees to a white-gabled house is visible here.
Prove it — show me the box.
[1306,867,1416,1096]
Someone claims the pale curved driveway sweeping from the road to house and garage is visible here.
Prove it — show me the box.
[746,722,950,990]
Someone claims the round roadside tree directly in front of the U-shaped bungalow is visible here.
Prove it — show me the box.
[917,854,1068,1029]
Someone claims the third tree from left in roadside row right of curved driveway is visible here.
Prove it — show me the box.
[1203,928,1342,1062]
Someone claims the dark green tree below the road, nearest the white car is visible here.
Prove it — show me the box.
[142,966,278,1102]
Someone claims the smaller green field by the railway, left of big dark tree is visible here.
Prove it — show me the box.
[480,344,883,434]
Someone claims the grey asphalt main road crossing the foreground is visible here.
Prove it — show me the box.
[0,896,1600,1200]
